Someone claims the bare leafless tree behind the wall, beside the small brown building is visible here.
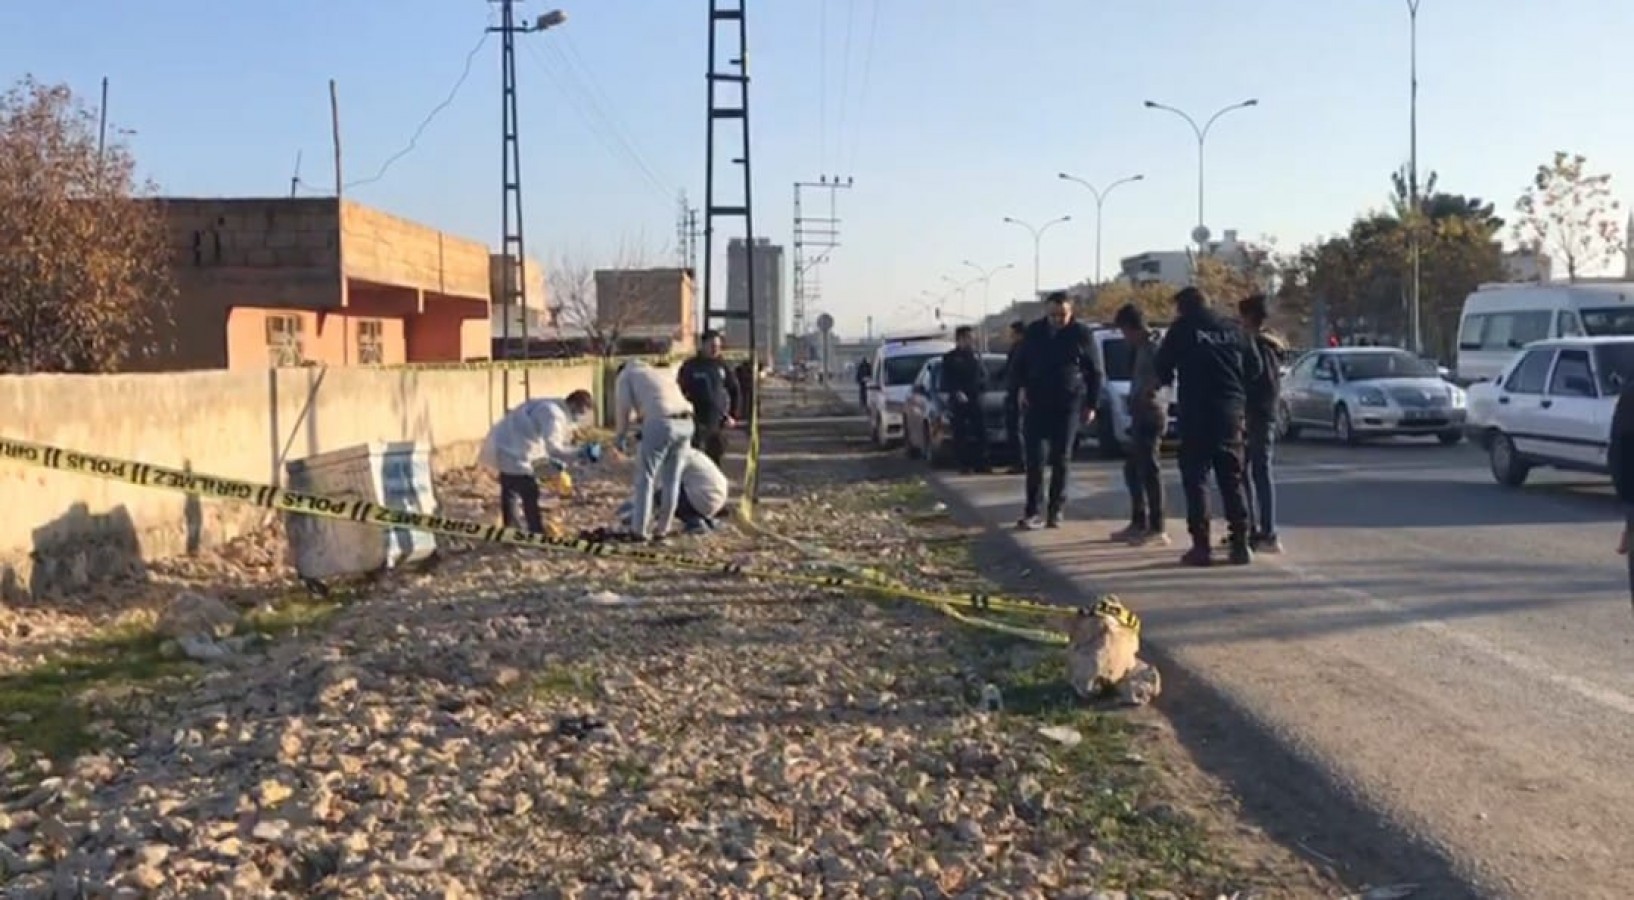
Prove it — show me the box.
[549,242,672,356]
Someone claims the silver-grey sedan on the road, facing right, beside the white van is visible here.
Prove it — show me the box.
[1276,346,1467,444]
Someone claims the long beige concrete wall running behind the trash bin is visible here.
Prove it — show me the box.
[0,363,598,598]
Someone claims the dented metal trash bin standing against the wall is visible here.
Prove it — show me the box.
[284,441,438,580]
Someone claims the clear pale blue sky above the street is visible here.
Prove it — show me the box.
[0,0,1634,333]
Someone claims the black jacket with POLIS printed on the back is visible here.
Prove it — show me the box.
[1157,309,1263,433]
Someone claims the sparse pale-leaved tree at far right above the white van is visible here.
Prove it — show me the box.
[1515,150,1626,281]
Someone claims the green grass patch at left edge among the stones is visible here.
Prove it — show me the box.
[0,626,196,761]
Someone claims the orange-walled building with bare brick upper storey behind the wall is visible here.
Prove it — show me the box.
[160,198,506,369]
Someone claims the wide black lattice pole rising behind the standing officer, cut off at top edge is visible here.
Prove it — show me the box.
[703,0,760,359]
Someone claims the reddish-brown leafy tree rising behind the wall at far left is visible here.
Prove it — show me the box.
[0,77,175,372]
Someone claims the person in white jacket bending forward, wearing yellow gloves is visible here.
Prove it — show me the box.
[477,390,601,534]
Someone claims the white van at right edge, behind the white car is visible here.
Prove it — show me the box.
[1456,281,1634,385]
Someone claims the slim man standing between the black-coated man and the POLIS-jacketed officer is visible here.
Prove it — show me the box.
[1113,304,1168,547]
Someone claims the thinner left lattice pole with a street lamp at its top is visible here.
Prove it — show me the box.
[489,0,567,410]
